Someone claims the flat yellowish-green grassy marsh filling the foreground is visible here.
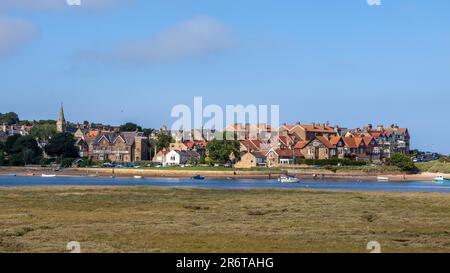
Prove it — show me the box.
[0,187,450,252]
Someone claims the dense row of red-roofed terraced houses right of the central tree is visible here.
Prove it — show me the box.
[232,123,410,166]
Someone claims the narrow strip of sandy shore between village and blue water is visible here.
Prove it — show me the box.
[0,167,445,182]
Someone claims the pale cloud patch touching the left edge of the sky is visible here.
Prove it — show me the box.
[0,16,38,57]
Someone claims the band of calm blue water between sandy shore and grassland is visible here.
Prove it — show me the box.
[0,176,450,193]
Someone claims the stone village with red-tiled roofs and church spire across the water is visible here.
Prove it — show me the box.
[0,106,410,169]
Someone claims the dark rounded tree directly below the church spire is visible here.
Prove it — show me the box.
[45,133,79,158]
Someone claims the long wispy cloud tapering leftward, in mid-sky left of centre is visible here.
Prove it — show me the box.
[83,16,233,64]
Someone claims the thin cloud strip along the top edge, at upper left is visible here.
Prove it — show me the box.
[0,0,135,10]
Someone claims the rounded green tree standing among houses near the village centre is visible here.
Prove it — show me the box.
[208,133,240,163]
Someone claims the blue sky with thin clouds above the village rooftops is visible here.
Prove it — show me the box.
[0,0,450,153]
